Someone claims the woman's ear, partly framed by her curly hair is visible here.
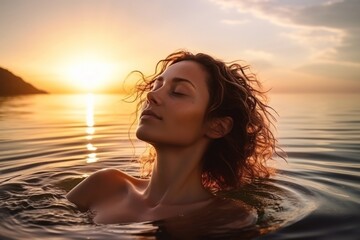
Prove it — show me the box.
[206,117,233,139]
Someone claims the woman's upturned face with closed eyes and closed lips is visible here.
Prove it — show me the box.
[136,61,209,146]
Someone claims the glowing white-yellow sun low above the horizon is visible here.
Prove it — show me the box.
[64,58,116,93]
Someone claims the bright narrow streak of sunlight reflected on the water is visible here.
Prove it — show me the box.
[86,93,99,163]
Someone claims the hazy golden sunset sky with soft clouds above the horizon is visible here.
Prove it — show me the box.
[0,0,360,92]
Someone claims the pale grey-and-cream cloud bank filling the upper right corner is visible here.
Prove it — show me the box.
[211,0,360,64]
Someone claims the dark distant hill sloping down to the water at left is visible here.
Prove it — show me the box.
[0,67,47,96]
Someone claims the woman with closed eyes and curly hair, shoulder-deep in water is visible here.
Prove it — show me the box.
[67,51,277,226]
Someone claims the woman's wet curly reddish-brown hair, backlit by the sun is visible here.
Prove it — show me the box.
[129,51,282,191]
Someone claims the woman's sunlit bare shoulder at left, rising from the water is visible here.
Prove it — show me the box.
[66,168,146,210]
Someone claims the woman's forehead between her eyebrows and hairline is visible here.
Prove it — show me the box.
[161,61,207,85]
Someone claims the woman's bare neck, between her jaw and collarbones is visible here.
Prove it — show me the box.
[144,142,211,205]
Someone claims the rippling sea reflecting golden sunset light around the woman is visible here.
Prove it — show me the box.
[0,92,360,240]
